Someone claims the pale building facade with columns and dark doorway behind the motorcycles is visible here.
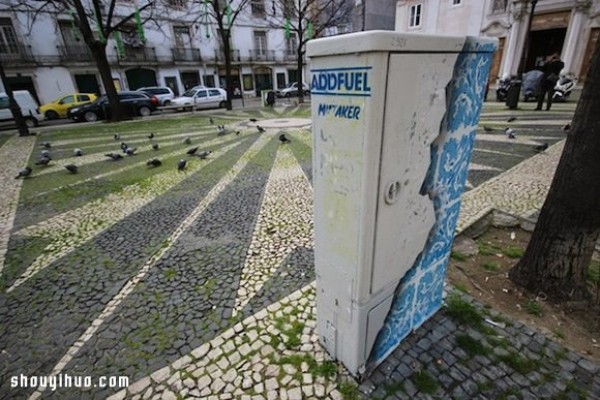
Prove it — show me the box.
[396,0,600,82]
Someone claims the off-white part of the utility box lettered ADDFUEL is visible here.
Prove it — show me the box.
[307,31,495,375]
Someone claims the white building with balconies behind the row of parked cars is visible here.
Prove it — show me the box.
[0,0,298,103]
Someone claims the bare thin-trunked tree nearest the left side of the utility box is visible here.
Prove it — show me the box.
[271,0,352,103]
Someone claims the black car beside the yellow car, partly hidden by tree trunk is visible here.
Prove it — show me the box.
[69,92,158,122]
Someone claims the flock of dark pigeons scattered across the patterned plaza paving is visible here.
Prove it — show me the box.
[15,117,291,179]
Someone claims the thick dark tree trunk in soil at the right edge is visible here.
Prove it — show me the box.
[509,42,600,302]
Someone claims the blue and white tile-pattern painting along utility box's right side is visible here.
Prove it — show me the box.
[368,38,496,368]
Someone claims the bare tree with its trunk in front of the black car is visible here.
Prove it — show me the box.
[0,0,158,121]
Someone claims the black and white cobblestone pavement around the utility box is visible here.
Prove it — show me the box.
[0,104,600,400]
